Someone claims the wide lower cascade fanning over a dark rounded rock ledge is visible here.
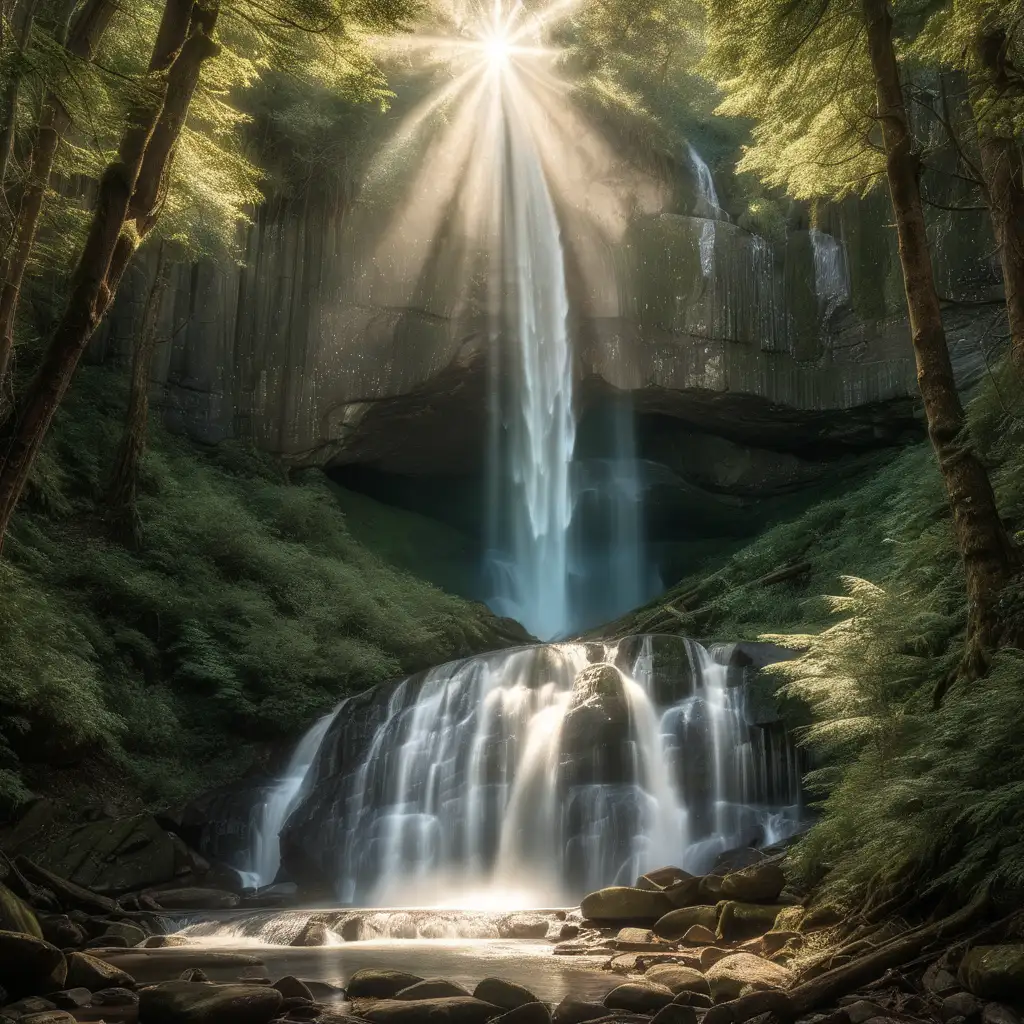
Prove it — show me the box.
[247,635,800,907]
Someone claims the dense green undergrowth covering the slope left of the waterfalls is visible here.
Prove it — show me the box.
[0,368,512,806]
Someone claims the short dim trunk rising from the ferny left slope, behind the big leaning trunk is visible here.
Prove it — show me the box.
[105,244,170,547]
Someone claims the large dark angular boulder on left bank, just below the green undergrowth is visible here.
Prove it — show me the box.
[24,814,175,896]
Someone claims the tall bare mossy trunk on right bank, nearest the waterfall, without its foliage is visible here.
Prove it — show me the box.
[862,0,1020,678]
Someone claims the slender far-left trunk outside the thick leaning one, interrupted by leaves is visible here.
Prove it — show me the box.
[0,0,118,393]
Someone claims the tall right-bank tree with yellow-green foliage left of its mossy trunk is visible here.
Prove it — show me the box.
[707,0,1020,677]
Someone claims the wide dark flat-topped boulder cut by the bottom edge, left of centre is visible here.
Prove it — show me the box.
[138,981,284,1024]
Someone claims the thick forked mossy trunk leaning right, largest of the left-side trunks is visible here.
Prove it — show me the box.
[0,0,218,544]
